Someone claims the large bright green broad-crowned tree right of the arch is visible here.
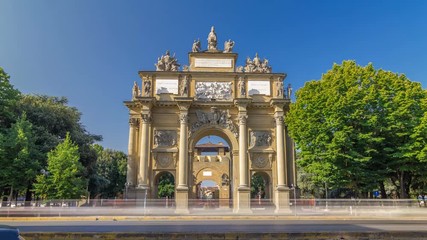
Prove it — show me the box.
[286,61,427,198]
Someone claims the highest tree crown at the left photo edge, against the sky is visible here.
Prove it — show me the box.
[0,67,20,129]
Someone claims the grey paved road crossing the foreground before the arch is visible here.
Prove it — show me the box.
[0,220,427,234]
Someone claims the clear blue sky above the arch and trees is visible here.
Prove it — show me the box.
[0,0,427,151]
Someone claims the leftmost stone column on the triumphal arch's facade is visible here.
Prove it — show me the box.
[125,118,139,187]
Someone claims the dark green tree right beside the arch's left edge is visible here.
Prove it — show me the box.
[93,144,127,198]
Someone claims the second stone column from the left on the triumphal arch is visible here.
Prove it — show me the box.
[138,113,151,189]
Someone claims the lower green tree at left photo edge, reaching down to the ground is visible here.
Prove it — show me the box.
[0,113,39,201]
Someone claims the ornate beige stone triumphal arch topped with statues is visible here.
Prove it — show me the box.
[125,27,296,213]
